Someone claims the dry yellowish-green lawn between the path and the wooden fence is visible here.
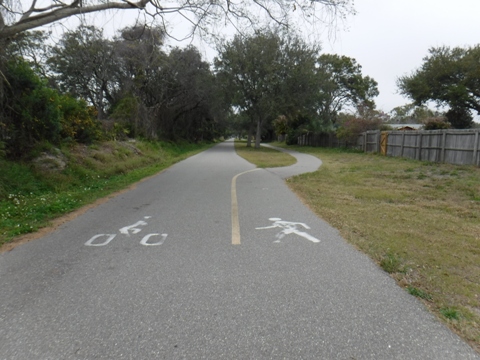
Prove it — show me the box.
[239,144,480,350]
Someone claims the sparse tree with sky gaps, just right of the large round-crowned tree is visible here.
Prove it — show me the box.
[316,54,378,129]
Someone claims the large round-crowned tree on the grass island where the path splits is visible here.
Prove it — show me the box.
[215,30,318,148]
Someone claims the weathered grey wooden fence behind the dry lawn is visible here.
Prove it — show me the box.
[298,129,480,166]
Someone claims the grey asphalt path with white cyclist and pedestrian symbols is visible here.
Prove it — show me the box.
[0,142,479,360]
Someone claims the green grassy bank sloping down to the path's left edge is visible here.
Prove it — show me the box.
[0,141,213,246]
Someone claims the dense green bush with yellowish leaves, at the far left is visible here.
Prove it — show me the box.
[0,58,101,158]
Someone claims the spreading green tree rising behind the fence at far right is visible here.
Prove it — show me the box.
[397,45,480,127]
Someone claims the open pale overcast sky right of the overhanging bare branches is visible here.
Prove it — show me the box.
[323,0,480,112]
